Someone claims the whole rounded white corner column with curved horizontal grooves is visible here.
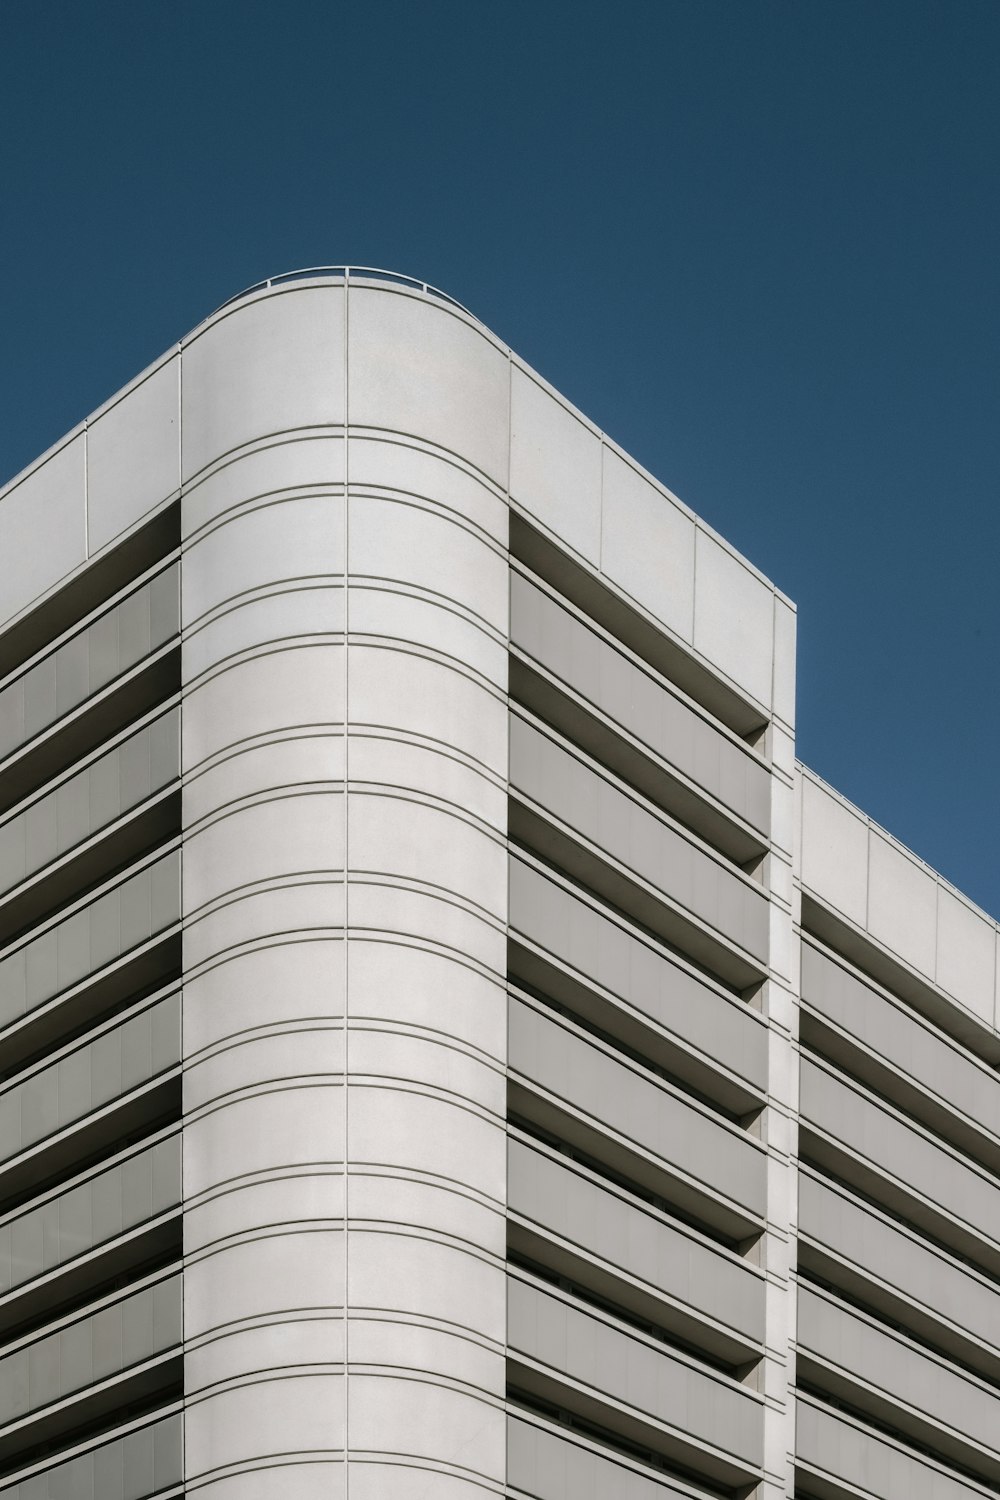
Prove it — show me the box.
[183,284,508,1500]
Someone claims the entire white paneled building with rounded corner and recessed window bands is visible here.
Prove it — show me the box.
[0,269,1000,1500]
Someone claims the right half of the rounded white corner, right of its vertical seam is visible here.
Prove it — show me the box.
[346,282,508,1500]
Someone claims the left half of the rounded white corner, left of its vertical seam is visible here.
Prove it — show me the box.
[181,285,352,1500]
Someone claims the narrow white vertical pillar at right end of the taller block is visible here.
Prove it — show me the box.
[762,596,799,1500]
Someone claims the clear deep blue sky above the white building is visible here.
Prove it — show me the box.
[0,0,1000,915]
